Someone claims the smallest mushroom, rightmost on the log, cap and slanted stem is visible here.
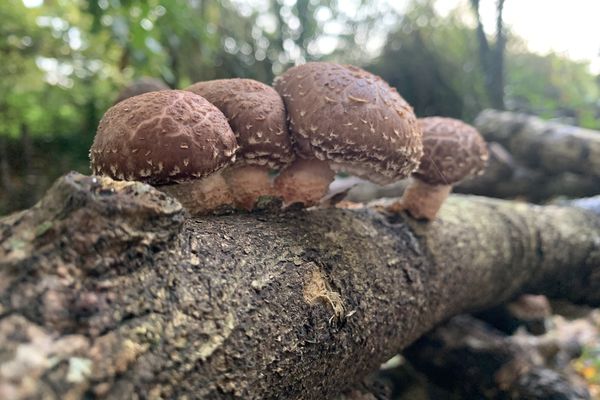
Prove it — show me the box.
[387,117,488,220]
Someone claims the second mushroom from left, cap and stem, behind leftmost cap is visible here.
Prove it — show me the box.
[186,78,294,210]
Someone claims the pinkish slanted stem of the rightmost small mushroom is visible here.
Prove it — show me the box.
[387,178,452,221]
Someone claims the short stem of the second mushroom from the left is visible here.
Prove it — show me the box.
[223,165,275,211]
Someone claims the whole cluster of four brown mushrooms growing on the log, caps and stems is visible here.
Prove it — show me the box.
[90,62,487,219]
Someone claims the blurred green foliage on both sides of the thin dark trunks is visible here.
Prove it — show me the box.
[368,0,600,129]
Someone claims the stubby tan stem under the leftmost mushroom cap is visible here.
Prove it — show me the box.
[157,172,233,214]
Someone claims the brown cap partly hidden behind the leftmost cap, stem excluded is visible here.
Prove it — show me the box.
[186,78,294,169]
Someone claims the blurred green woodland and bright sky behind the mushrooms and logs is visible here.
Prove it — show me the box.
[0,0,600,215]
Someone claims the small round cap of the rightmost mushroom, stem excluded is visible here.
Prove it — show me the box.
[414,117,488,185]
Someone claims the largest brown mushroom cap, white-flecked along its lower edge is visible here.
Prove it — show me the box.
[274,62,422,184]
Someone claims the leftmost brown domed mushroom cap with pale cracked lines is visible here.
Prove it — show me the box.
[90,90,237,185]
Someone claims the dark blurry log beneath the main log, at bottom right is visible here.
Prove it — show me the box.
[404,315,590,400]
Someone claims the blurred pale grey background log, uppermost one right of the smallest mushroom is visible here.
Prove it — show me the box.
[475,110,600,180]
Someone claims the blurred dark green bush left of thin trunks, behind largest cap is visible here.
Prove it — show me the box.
[369,1,487,120]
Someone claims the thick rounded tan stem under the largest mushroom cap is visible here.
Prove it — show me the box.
[275,158,335,207]
